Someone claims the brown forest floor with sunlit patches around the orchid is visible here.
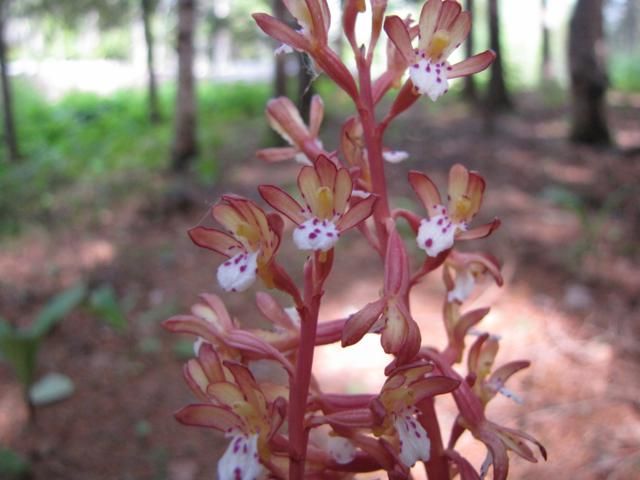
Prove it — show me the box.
[0,91,640,480]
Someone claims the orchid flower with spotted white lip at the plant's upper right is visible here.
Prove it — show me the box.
[385,0,495,101]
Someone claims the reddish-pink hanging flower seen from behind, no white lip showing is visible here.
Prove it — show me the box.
[342,228,421,362]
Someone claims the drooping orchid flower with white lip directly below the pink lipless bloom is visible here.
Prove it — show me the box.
[371,363,459,468]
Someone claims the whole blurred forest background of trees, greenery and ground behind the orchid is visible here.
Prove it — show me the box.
[0,0,640,480]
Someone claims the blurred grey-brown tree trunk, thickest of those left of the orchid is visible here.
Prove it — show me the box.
[171,0,197,172]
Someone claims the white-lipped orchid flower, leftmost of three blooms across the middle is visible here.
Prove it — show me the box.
[189,195,283,292]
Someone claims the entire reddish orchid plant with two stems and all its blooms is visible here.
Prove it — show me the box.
[165,0,546,480]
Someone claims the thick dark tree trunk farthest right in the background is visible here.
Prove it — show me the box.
[569,0,611,145]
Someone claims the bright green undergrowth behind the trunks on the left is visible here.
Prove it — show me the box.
[0,81,269,234]
